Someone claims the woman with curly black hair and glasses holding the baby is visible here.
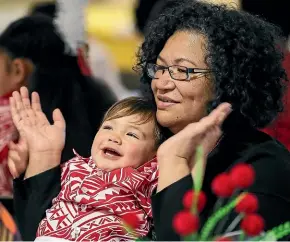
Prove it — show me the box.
[15,0,290,240]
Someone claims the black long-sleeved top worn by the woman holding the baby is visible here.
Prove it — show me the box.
[14,127,290,241]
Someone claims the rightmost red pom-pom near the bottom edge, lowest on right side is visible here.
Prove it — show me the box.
[241,214,264,236]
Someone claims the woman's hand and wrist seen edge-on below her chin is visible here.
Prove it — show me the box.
[157,103,231,191]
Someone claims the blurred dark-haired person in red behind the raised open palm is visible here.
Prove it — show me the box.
[0,0,116,217]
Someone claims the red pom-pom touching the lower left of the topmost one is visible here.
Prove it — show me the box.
[211,173,234,197]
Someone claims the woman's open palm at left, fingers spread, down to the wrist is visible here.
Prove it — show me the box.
[10,87,65,155]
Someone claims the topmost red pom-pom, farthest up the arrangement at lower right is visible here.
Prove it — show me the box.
[230,164,255,188]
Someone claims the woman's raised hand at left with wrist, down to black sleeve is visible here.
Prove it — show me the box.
[10,87,65,178]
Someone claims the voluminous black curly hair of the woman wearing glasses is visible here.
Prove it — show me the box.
[135,0,287,128]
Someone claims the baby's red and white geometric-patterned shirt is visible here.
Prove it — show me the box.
[37,152,158,241]
